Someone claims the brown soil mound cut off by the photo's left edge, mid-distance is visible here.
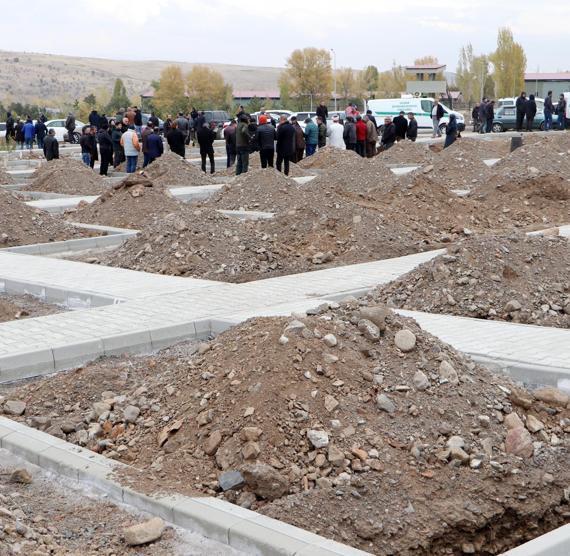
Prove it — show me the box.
[0,189,87,248]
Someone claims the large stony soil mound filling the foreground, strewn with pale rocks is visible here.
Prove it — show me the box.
[4,308,570,556]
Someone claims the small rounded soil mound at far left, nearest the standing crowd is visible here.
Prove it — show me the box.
[22,158,108,195]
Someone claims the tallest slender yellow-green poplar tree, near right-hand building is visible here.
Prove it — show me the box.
[489,27,526,97]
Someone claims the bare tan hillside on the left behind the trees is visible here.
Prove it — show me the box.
[0,50,281,103]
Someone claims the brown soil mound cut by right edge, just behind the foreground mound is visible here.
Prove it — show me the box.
[374,235,570,328]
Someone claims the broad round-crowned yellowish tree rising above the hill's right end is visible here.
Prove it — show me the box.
[279,47,333,108]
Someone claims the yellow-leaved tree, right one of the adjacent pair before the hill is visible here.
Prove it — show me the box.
[186,66,233,110]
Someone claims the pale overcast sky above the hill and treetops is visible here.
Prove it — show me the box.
[5,0,570,72]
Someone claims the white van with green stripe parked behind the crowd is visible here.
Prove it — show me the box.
[367,96,465,133]
